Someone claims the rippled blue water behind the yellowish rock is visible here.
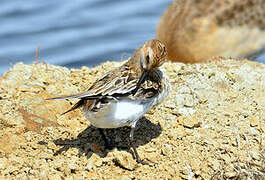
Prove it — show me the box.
[0,0,265,75]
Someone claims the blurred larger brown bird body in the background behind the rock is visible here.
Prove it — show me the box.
[156,0,265,63]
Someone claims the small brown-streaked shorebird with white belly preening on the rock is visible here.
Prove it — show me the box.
[48,40,170,164]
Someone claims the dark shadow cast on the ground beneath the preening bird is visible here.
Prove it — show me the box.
[50,118,162,158]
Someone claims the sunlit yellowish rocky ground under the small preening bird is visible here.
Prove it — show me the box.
[0,58,265,179]
